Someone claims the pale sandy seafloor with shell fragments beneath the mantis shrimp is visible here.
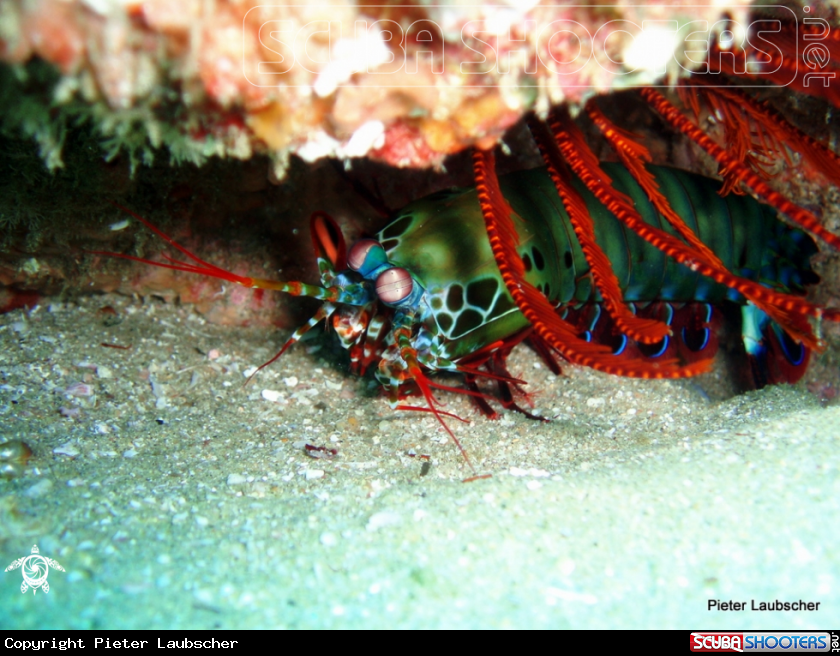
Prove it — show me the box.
[0,296,840,629]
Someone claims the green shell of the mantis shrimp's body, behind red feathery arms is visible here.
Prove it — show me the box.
[378,164,816,360]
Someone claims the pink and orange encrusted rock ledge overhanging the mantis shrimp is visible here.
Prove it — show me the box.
[0,0,746,175]
